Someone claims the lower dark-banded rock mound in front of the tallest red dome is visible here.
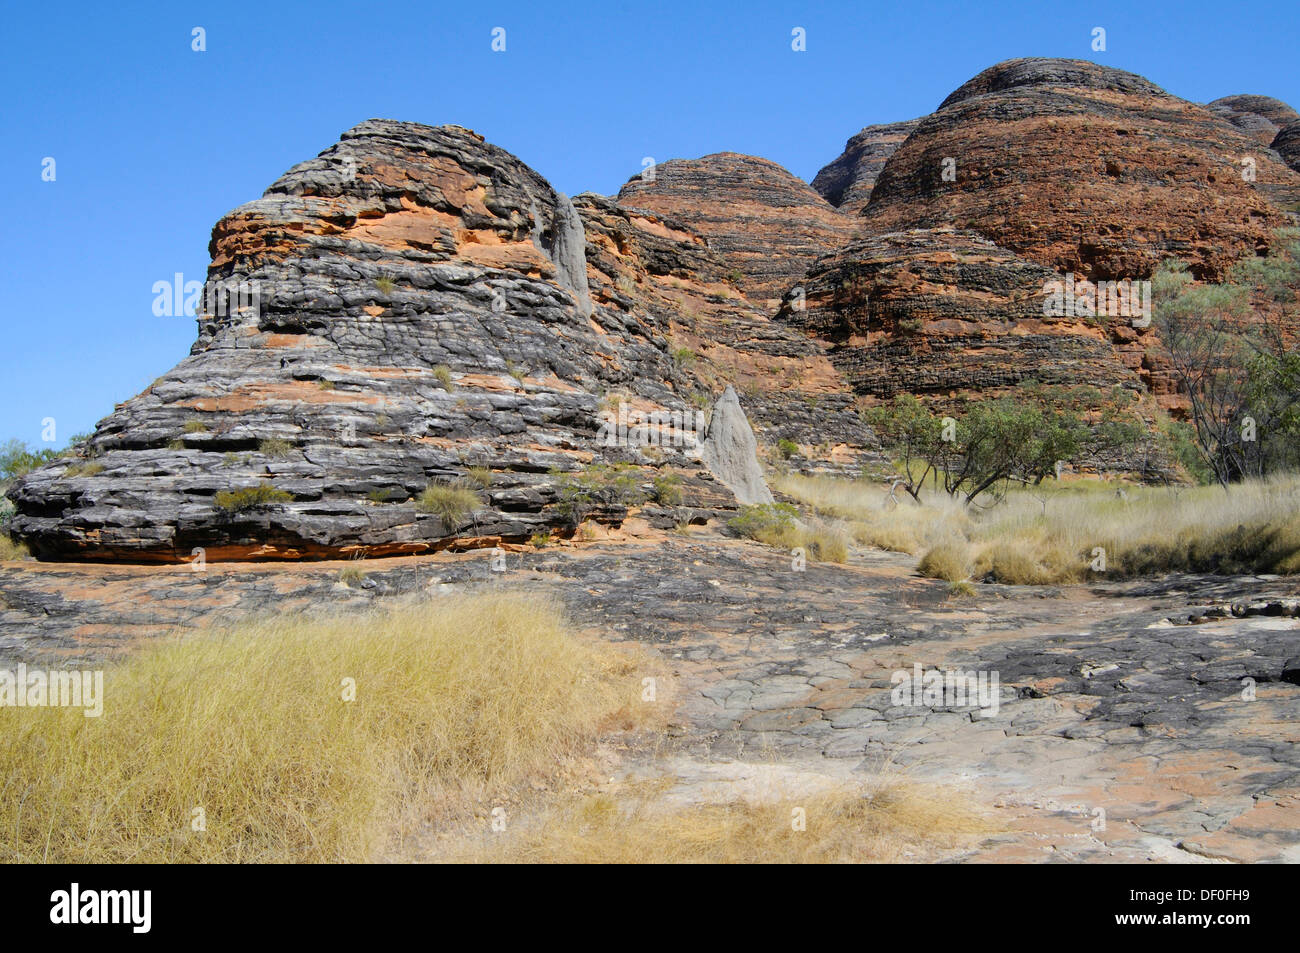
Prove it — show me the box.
[779,229,1143,398]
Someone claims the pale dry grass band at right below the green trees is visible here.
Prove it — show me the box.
[776,475,1300,585]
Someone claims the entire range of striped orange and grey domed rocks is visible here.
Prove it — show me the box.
[17,59,1300,560]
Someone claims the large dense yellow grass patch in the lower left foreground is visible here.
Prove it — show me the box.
[0,594,650,863]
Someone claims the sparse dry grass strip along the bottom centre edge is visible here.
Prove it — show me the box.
[441,781,991,863]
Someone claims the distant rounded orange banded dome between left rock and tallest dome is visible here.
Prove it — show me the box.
[618,152,857,304]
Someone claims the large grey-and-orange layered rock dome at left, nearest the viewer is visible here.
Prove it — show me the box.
[10,121,754,560]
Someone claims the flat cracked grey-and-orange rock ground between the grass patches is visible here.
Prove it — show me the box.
[0,519,1300,862]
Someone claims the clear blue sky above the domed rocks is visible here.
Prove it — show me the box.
[0,0,1300,446]
